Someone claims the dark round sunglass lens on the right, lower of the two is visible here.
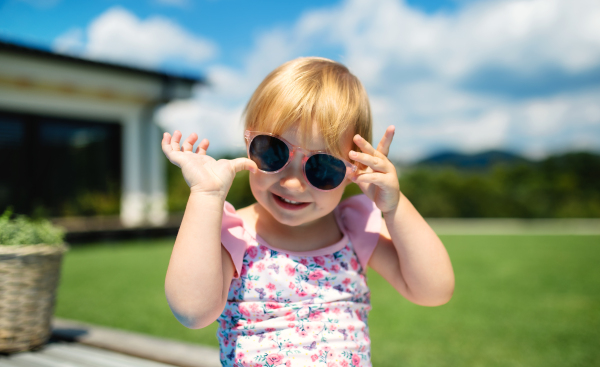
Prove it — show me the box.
[304,154,346,190]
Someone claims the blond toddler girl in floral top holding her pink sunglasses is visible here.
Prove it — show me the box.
[162,57,454,367]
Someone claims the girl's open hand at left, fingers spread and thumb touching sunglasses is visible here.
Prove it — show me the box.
[161,130,258,200]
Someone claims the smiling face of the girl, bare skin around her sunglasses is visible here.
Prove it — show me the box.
[250,126,352,226]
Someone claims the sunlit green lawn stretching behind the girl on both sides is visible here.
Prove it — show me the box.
[56,236,600,367]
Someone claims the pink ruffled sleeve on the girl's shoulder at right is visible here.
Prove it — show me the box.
[335,194,382,271]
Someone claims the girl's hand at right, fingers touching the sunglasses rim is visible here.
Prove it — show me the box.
[348,126,400,214]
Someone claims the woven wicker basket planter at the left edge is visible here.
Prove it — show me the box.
[0,244,67,353]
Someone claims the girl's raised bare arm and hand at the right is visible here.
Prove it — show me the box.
[350,126,454,306]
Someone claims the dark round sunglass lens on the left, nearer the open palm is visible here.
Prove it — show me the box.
[249,135,290,172]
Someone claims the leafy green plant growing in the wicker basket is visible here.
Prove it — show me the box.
[0,208,65,245]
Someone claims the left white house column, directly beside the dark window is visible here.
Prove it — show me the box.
[121,112,146,227]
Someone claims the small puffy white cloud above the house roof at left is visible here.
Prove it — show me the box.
[54,7,217,69]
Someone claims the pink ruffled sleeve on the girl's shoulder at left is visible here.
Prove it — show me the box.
[221,202,248,278]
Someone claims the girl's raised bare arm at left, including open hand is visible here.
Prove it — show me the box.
[162,131,256,329]
